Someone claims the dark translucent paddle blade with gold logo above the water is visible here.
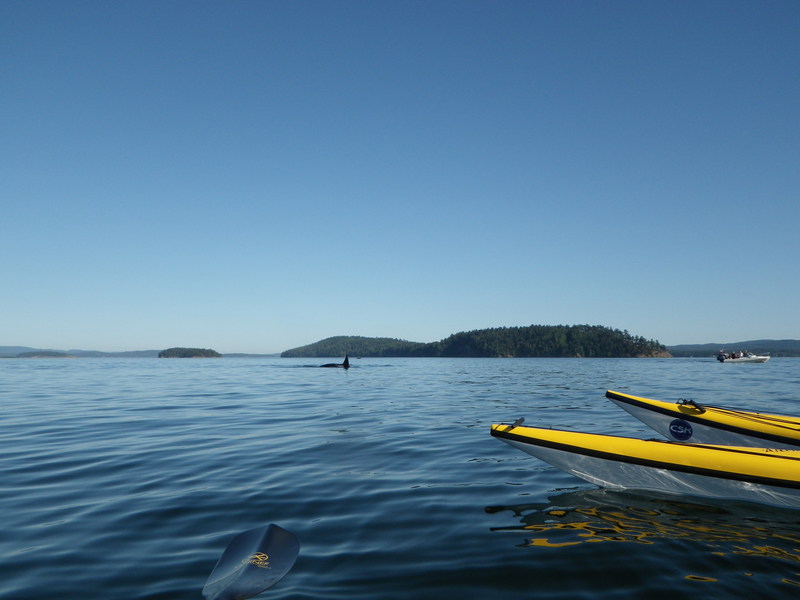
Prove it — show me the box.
[203,525,300,600]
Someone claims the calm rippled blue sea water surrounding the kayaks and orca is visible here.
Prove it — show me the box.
[0,358,800,600]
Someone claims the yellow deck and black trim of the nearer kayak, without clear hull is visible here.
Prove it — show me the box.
[491,424,800,490]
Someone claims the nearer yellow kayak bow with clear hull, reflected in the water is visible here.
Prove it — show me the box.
[491,421,800,508]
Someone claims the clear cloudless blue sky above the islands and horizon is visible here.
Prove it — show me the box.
[0,0,800,352]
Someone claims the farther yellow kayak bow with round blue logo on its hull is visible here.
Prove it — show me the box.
[606,390,800,450]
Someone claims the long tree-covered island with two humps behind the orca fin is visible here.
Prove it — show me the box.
[281,325,671,358]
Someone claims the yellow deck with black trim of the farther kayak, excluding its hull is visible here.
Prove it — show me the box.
[606,390,800,446]
